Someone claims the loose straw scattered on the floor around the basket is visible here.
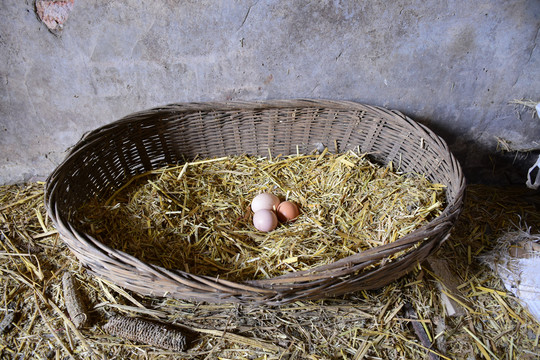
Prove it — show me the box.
[0,183,540,360]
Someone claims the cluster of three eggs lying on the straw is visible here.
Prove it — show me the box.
[251,193,300,232]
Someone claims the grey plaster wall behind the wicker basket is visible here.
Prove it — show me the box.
[0,0,540,184]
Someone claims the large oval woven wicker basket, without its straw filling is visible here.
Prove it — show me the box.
[45,100,465,305]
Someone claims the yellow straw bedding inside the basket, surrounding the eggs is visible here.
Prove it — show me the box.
[78,149,444,281]
